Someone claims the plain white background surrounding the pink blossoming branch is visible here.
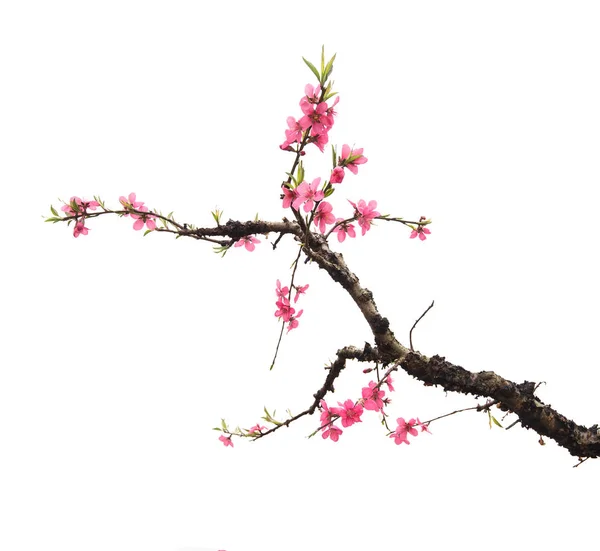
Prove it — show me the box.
[0,1,600,551]
